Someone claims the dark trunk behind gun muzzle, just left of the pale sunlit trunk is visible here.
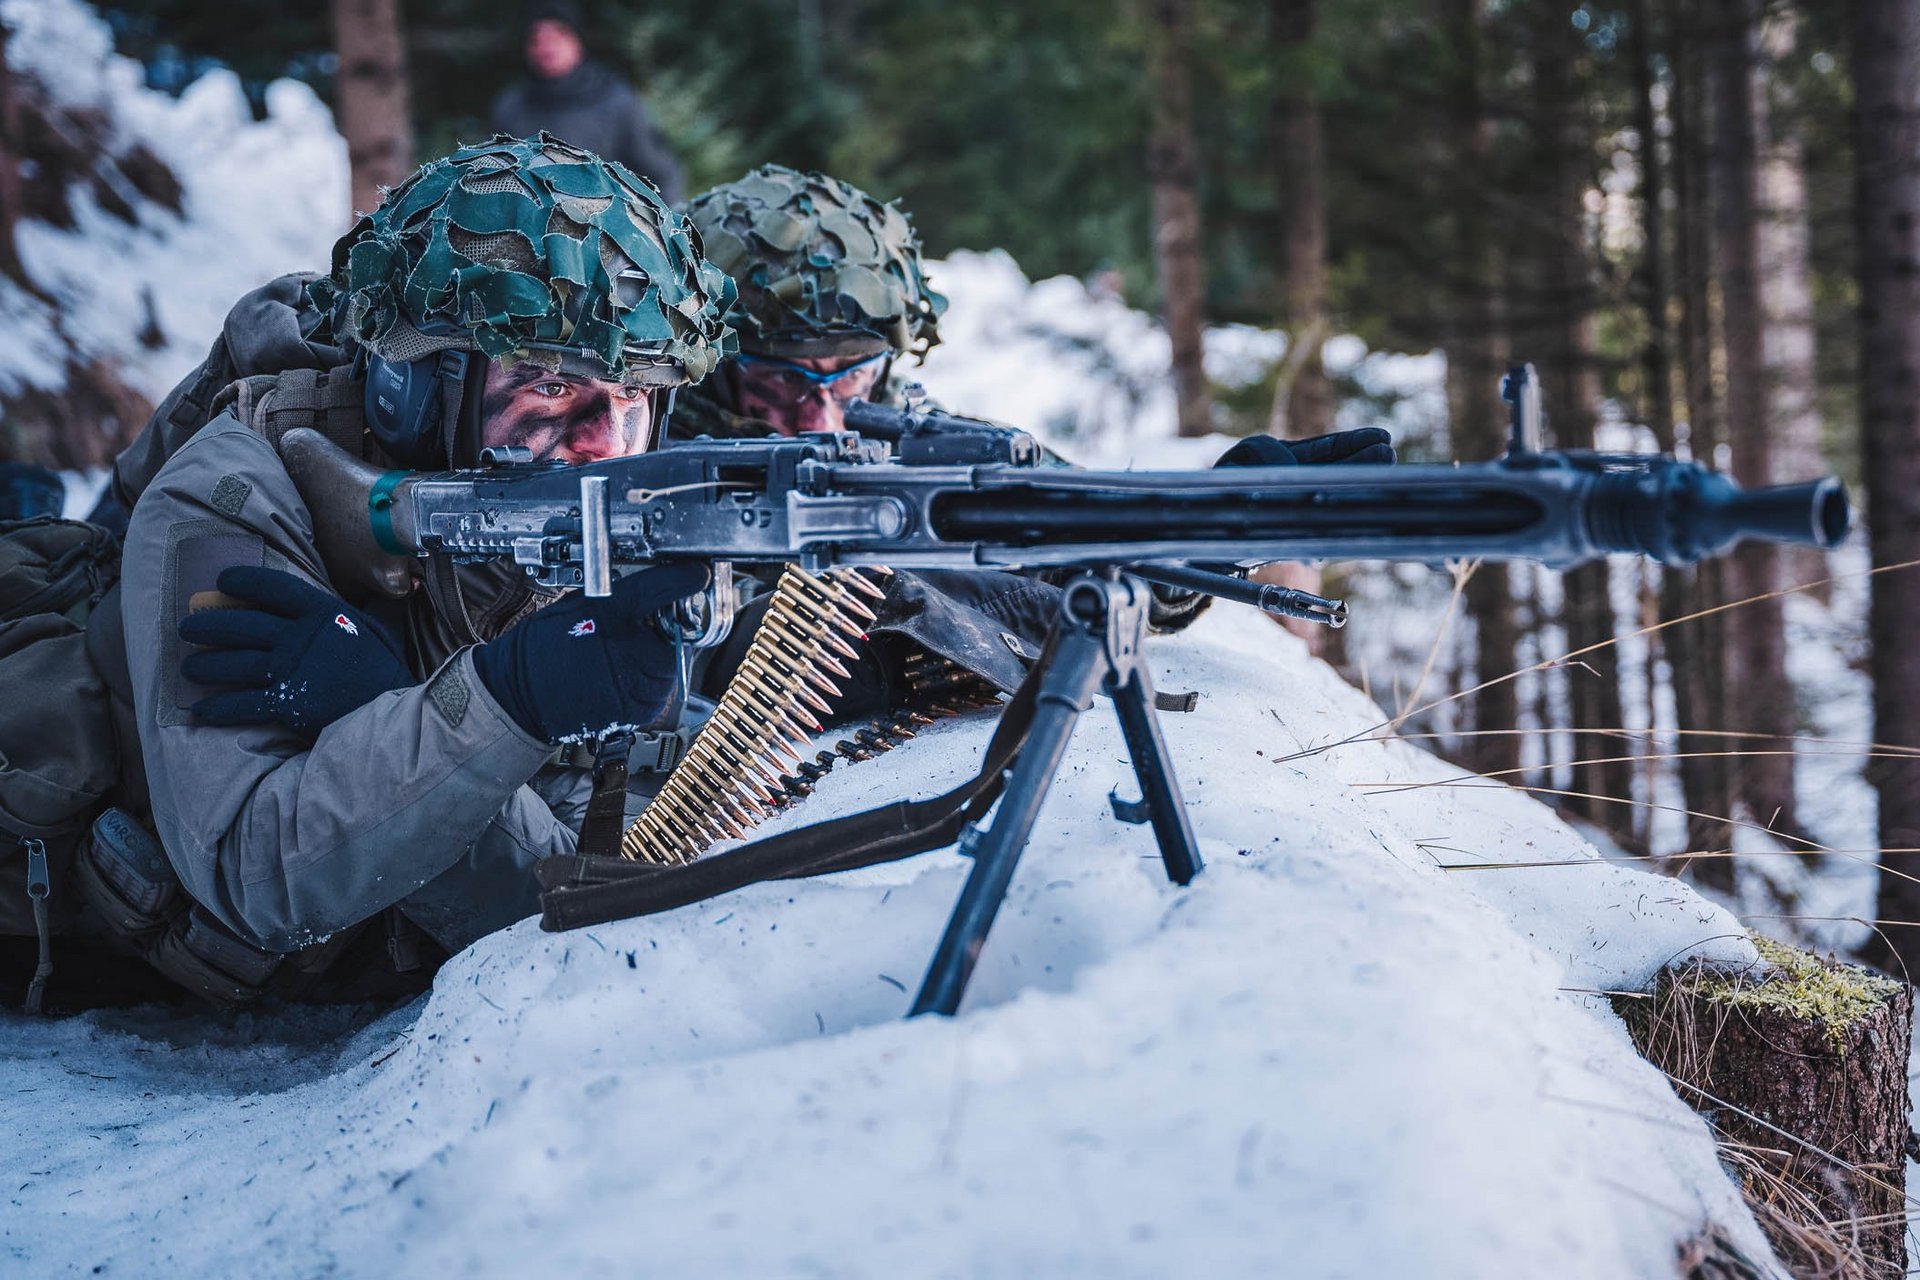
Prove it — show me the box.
[1661,0,1736,892]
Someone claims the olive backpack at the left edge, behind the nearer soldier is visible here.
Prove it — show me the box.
[0,516,119,1009]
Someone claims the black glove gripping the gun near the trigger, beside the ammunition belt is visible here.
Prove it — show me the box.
[474,564,710,743]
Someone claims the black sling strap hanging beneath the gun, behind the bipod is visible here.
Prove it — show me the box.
[538,658,1046,933]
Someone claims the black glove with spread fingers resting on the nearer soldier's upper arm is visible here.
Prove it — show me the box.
[180,564,417,735]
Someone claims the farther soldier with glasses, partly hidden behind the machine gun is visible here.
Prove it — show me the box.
[668,165,1394,716]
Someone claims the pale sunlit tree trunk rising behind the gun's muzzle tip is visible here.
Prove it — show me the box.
[1753,6,1832,583]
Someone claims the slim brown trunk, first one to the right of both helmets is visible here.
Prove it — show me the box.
[1146,0,1213,436]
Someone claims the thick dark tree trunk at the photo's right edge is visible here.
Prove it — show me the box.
[1851,0,1920,975]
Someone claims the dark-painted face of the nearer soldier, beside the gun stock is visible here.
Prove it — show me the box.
[480,361,657,462]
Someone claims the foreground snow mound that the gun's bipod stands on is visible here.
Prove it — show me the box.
[0,606,1766,1280]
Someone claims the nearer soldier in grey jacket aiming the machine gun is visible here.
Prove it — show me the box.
[61,134,733,1006]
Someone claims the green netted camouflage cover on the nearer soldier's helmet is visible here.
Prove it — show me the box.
[311,134,735,386]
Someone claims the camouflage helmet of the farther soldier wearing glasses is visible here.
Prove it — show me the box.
[687,165,947,357]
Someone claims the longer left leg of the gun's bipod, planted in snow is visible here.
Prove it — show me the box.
[906,594,1114,1017]
